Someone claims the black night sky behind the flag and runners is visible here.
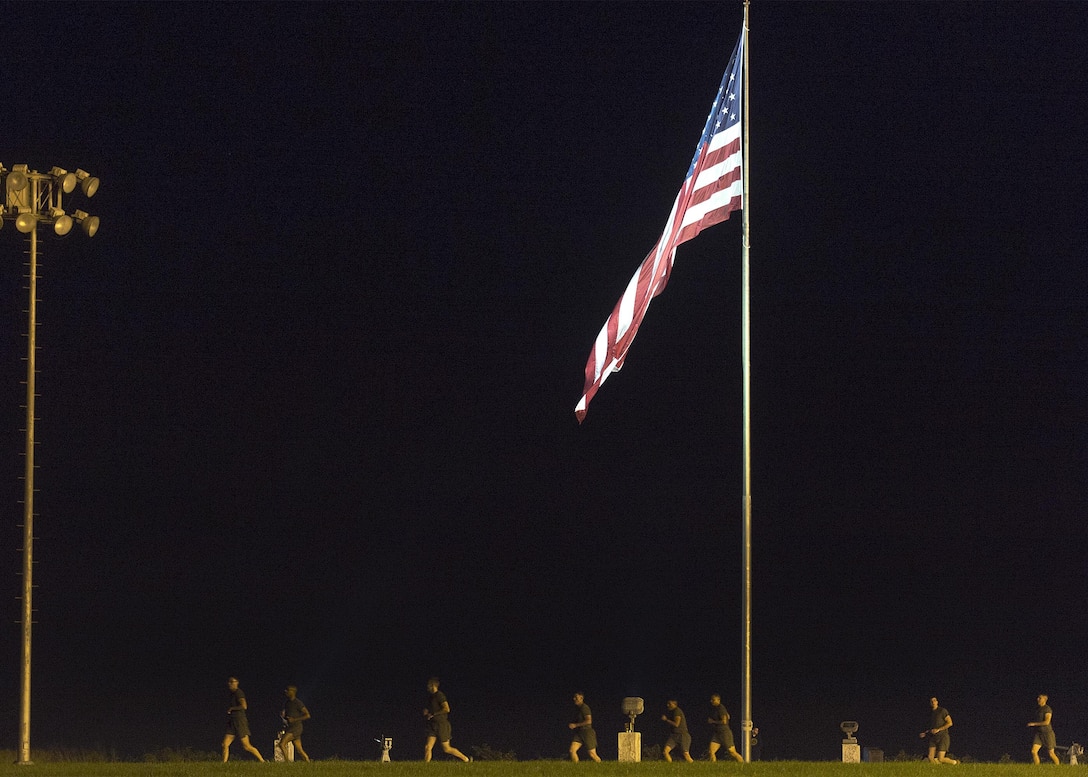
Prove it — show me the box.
[0,2,1088,760]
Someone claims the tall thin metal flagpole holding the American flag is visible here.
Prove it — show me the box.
[741,0,752,762]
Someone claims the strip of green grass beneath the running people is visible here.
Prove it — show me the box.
[0,759,1070,777]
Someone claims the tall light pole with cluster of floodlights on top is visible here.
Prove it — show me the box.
[0,164,98,764]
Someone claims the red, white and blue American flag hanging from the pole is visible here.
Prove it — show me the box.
[574,32,744,423]
